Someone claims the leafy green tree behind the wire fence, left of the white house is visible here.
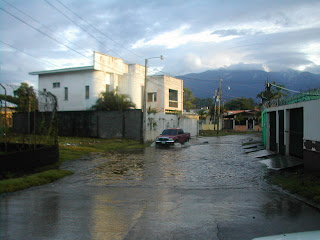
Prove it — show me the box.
[11,82,38,112]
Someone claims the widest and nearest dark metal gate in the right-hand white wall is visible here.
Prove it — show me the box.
[289,108,303,158]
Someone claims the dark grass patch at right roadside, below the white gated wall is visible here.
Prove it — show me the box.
[268,169,320,204]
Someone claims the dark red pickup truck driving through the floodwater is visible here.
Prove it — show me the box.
[156,128,190,145]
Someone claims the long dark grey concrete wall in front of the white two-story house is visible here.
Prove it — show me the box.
[13,109,142,140]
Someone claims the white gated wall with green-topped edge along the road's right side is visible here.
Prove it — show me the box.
[262,89,320,171]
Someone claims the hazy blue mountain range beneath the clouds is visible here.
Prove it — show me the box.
[177,69,320,101]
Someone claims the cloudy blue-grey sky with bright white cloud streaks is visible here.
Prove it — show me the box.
[0,0,320,87]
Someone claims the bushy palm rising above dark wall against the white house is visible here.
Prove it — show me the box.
[92,91,135,111]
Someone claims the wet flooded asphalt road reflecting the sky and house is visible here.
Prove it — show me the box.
[0,135,320,240]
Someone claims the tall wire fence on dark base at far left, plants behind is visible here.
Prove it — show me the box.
[0,83,59,177]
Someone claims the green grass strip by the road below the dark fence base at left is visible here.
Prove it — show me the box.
[0,169,73,193]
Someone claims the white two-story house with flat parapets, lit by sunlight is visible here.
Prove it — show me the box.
[30,52,183,112]
